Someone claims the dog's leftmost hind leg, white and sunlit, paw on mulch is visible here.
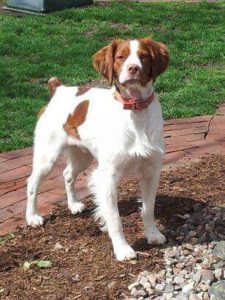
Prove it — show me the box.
[26,143,63,227]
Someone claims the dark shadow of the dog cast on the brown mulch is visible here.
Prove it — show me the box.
[54,194,216,251]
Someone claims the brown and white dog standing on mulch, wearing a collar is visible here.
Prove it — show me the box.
[26,38,169,260]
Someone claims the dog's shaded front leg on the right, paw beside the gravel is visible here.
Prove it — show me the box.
[141,155,166,245]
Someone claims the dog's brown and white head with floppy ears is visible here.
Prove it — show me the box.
[93,38,169,86]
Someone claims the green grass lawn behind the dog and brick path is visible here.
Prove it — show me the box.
[0,2,225,152]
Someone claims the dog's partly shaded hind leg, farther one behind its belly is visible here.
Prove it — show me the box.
[63,146,93,214]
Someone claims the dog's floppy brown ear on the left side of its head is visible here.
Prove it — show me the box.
[93,40,123,85]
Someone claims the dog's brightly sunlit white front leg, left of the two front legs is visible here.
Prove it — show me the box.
[92,167,136,261]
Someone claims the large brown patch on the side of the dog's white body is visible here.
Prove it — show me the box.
[63,100,89,140]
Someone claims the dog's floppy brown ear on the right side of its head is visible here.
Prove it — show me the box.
[141,38,169,81]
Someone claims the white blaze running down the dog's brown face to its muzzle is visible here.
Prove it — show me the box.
[119,40,142,84]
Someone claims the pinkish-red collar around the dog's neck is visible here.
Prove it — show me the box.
[115,91,155,111]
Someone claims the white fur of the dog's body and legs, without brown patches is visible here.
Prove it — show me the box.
[26,39,165,260]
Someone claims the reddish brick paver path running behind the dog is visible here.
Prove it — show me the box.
[0,104,225,236]
